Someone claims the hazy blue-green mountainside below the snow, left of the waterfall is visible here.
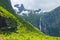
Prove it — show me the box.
[20,13,43,29]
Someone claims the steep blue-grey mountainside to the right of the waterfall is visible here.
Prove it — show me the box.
[41,6,60,36]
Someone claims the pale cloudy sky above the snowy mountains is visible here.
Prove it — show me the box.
[11,0,60,11]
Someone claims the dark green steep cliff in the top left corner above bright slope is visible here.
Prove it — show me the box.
[0,0,14,13]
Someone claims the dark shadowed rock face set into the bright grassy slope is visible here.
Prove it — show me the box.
[0,15,17,31]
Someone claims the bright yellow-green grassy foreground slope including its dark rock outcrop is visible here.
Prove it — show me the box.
[0,0,60,40]
